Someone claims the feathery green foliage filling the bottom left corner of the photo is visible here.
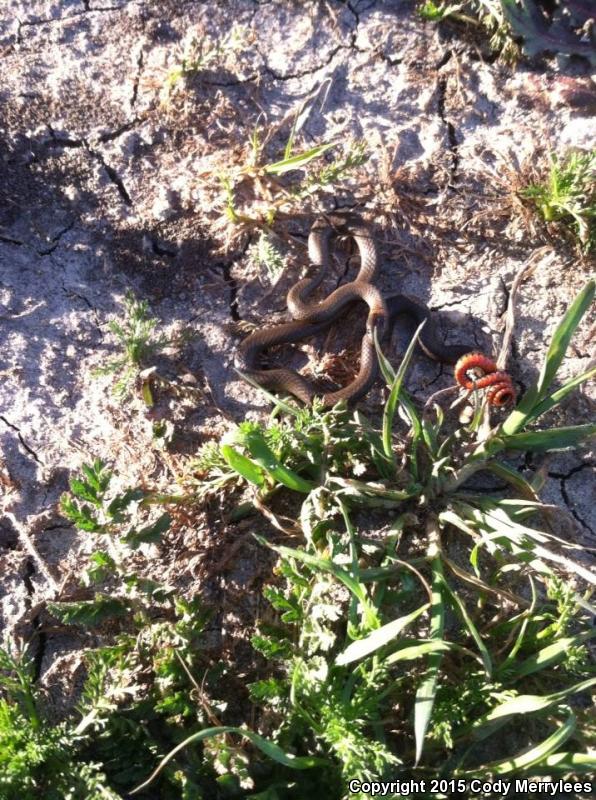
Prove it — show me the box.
[0,598,225,800]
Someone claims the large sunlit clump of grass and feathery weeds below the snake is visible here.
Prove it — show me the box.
[135,283,596,800]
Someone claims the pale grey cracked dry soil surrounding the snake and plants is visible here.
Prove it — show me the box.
[0,0,596,707]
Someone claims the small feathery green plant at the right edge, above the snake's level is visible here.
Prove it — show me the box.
[520,150,596,250]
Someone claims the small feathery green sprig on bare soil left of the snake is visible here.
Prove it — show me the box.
[95,291,172,405]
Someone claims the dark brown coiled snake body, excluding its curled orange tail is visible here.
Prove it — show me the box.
[235,216,474,407]
